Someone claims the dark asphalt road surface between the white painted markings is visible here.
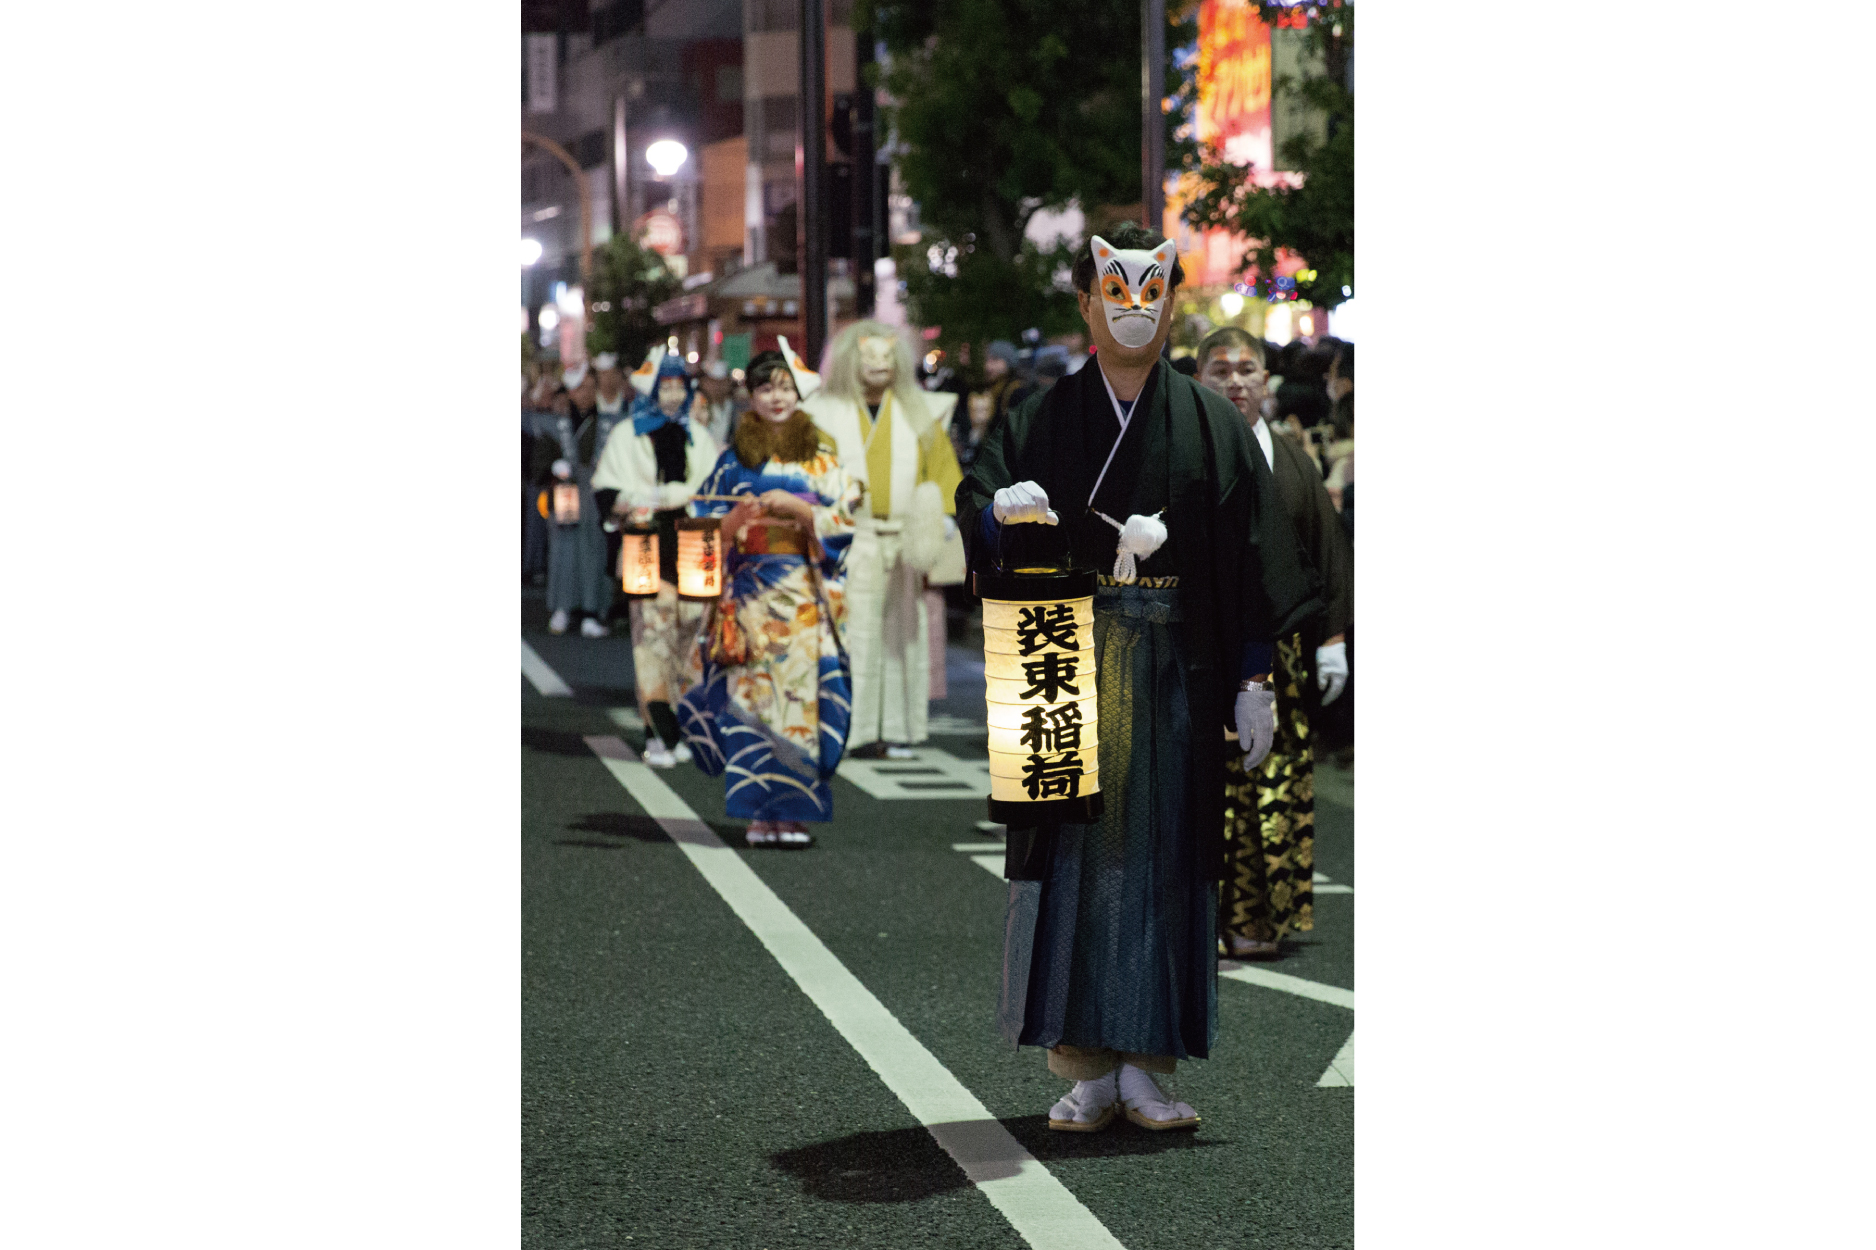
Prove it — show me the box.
[522,597,1354,1250]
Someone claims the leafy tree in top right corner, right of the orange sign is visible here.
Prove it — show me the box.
[1182,4,1354,308]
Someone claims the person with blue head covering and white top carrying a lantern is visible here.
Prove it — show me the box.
[593,345,717,768]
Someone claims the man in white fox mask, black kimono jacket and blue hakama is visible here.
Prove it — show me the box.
[957,225,1319,1132]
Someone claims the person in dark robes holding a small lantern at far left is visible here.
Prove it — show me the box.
[529,360,612,638]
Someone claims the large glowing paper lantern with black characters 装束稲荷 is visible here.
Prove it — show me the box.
[977,569,1101,830]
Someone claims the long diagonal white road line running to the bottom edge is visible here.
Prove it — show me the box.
[585,736,1124,1250]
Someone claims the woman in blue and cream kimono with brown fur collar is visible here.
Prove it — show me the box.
[677,351,861,848]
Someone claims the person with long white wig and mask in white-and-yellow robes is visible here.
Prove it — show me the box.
[801,321,964,758]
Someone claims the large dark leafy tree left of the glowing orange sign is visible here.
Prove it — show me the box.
[854,0,1191,354]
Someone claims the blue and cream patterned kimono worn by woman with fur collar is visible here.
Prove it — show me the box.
[677,441,861,820]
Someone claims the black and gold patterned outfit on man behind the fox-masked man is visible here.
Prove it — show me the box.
[1218,430,1354,942]
